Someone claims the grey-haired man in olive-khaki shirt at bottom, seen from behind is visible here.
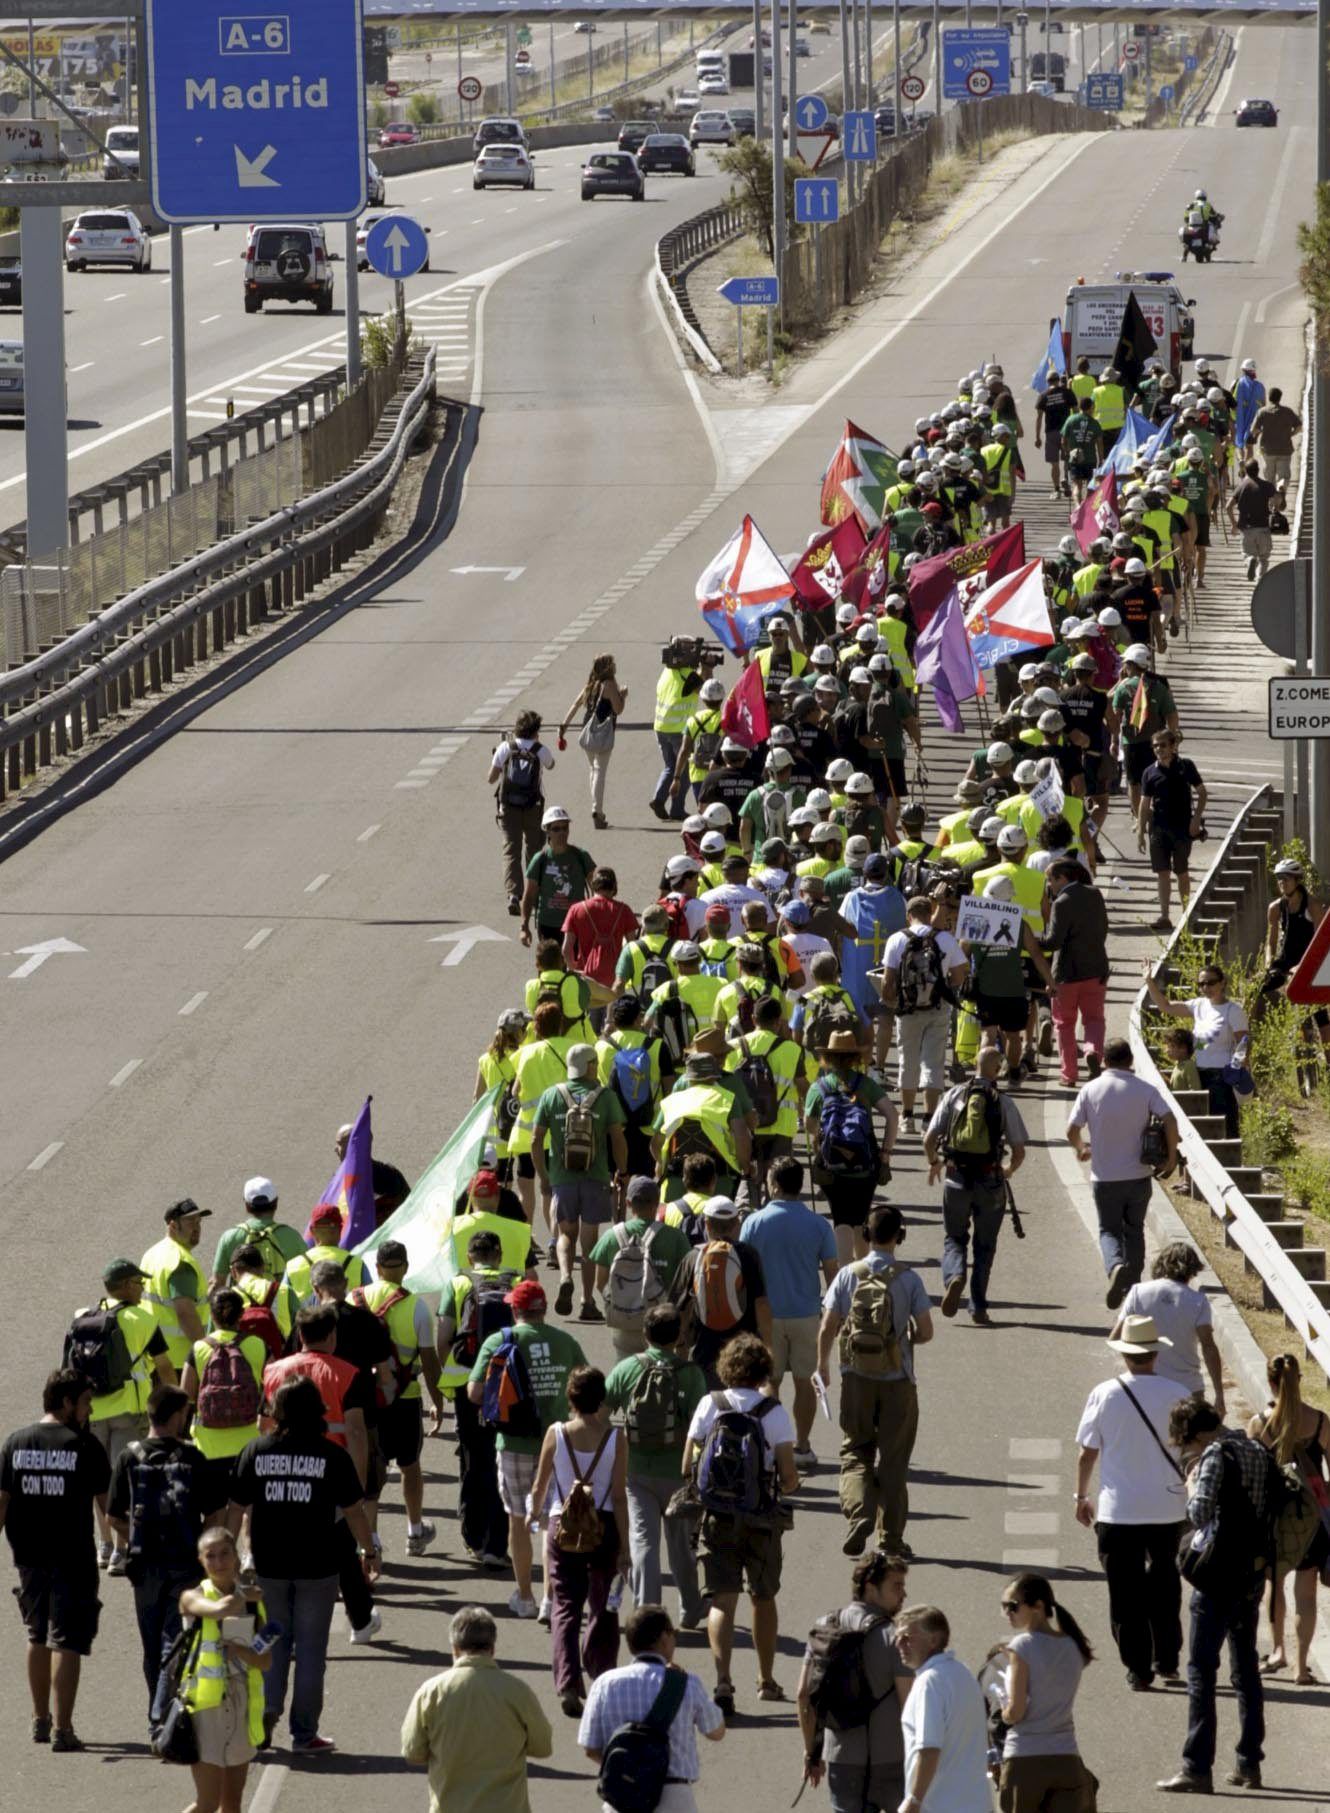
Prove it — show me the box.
[402,1605,554,1813]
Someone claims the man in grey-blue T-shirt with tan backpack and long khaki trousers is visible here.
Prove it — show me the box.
[817,1202,933,1559]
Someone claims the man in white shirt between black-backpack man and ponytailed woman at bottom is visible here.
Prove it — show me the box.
[895,1605,993,1813]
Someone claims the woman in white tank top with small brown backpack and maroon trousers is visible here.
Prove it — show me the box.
[531,1365,629,1719]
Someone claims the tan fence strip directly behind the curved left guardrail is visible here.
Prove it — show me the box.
[0,350,404,669]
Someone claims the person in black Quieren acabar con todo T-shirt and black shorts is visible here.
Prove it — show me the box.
[0,1369,111,1750]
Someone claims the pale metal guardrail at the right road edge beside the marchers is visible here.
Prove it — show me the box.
[1129,787,1330,1383]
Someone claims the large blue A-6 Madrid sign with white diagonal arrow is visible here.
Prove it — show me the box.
[147,0,366,221]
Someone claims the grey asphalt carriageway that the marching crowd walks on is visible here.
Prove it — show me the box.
[0,14,1330,1813]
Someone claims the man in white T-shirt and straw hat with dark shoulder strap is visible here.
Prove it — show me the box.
[1076,1316,1187,1693]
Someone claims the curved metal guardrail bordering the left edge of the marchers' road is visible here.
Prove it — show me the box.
[0,348,435,800]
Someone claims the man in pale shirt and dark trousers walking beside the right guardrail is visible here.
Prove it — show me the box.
[1067,1039,1178,1309]
